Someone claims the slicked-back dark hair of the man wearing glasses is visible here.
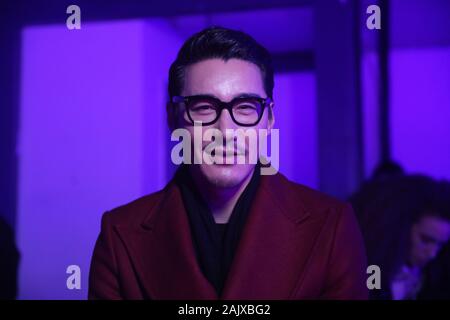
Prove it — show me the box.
[169,27,274,98]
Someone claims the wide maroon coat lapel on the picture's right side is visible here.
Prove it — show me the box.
[222,175,322,300]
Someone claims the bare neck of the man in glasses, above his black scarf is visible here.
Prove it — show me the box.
[193,168,255,223]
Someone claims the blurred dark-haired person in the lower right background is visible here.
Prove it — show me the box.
[351,175,450,300]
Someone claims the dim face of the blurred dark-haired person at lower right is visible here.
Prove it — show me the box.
[410,215,450,267]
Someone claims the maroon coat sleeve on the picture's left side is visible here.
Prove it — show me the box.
[88,213,122,300]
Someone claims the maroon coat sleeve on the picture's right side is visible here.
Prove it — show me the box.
[322,205,368,300]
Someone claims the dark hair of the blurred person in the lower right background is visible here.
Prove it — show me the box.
[350,175,450,299]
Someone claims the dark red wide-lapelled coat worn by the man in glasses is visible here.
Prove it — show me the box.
[89,174,368,300]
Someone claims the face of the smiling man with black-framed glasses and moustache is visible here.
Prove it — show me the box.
[179,59,273,188]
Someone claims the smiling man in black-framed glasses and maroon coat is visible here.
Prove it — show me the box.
[89,27,367,299]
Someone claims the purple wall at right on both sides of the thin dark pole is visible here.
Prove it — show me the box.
[361,0,450,179]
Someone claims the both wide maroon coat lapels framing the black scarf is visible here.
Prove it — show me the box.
[116,174,322,300]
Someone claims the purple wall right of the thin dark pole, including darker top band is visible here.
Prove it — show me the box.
[389,0,450,179]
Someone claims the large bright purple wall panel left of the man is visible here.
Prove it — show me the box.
[17,21,180,299]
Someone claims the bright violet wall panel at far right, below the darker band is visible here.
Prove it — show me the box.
[390,46,450,179]
